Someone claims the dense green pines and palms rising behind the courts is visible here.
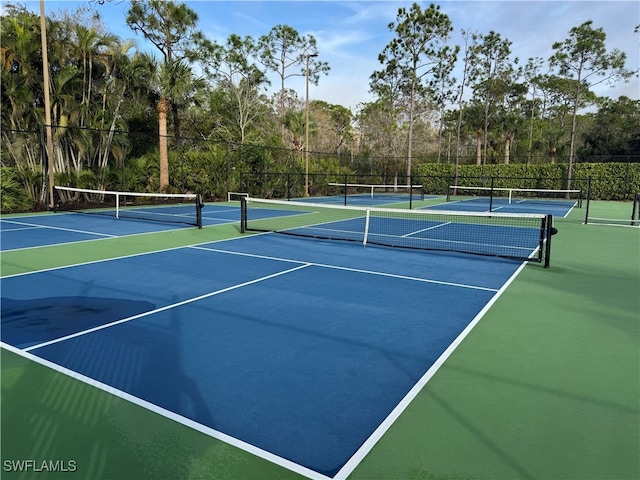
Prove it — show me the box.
[0,0,640,211]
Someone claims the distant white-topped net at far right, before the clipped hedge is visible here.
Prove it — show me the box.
[447,185,582,208]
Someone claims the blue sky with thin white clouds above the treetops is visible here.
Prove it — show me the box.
[12,0,640,109]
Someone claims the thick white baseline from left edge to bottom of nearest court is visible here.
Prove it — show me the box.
[0,342,331,480]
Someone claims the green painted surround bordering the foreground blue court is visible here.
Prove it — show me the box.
[1,202,640,480]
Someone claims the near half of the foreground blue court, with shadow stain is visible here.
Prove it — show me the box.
[1,230,520,478]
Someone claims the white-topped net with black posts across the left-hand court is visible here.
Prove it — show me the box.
[54,186,203,228]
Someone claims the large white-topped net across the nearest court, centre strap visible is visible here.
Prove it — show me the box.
[240,198,554,267]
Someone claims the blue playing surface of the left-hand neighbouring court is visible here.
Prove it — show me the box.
[0,204,239,251]
